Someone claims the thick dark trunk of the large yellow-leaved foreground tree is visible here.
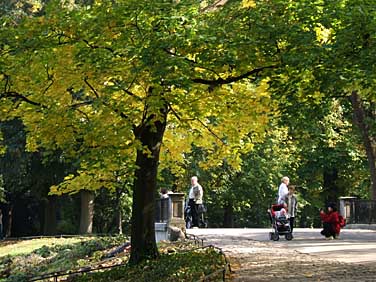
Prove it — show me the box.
[129,103,167,264]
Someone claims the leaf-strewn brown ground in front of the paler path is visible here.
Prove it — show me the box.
[226,242,376,281]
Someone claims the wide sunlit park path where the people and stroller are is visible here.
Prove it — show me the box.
[187,228,376,282]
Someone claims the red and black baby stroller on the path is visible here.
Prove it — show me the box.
[268,205,293,241]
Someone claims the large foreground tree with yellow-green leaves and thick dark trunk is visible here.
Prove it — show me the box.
[0,1,274,262]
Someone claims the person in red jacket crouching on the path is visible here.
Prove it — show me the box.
[320,204,341,239]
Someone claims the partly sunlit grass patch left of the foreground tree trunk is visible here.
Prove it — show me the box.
[0,237,128,282]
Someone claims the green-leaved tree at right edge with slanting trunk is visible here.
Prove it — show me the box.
[272,0,376,197]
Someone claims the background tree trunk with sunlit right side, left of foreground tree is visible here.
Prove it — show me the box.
[80,190,94,234]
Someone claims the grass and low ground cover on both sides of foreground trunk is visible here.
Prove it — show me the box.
[0,236,225,282]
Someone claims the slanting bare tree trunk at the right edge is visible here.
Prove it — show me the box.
[350,91,376,200]
